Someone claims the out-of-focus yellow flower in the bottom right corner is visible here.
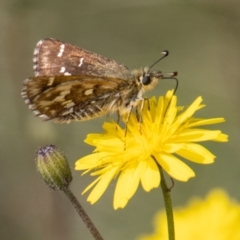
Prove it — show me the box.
[138,189,240,240]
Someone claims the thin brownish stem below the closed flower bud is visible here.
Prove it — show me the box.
[63,188,103,240]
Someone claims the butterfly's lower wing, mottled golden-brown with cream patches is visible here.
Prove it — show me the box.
[22,76,139,122]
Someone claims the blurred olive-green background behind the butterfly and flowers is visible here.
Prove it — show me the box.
[0,0,240,240]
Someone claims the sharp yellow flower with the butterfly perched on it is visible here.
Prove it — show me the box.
[75,91,227,209]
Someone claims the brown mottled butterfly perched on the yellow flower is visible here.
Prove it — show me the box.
[22,38,176,122]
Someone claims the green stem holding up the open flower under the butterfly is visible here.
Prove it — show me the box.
[159,166,175,240]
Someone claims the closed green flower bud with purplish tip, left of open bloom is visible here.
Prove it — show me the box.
[36,145,72,190]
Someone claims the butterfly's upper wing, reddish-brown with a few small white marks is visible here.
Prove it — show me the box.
[33,38,132,80]
